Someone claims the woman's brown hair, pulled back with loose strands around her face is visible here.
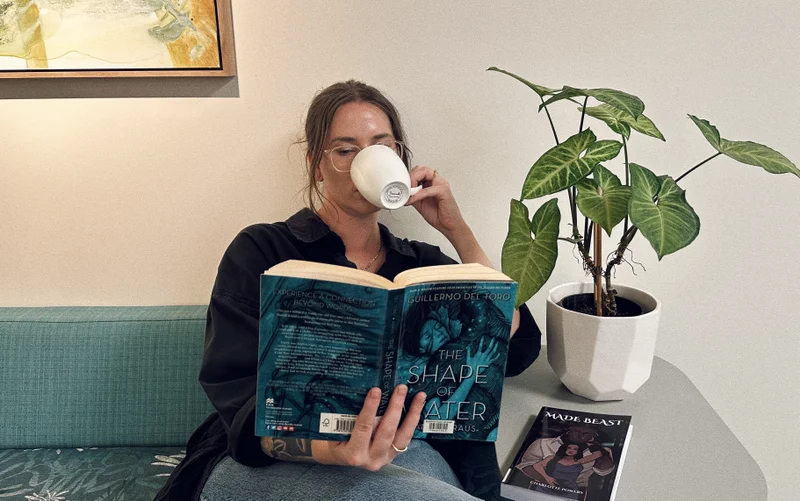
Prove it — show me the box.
[300,80,411,212]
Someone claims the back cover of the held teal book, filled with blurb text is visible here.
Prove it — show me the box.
[256,275,389,440]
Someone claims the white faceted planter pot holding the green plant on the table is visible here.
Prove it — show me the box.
[547,282,661,400]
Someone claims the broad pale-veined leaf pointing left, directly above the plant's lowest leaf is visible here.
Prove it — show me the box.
[522,129,622,200]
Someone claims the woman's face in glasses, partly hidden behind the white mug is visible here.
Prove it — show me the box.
[318,102,394,216]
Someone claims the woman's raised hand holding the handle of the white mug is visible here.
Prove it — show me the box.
[406,165,466,239]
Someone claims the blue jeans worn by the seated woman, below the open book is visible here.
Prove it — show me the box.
[200,440,477,501]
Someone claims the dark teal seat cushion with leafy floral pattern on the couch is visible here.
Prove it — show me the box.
[0,447,185,501]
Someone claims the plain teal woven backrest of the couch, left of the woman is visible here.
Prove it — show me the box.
[0,306,213,448]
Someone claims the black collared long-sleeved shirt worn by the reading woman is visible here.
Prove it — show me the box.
[155,209,541,501]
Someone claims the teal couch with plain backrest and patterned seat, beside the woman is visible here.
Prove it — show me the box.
[0,306,213,501]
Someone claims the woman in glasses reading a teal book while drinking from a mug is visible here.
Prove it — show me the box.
[156,81,540,501]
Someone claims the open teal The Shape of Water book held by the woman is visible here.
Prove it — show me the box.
[255,261,517,441]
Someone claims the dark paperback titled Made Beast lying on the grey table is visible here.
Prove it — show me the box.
[501,407,632,501]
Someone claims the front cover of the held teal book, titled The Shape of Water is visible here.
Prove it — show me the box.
[395,282,517,441]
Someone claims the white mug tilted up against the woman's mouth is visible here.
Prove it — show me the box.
[350,144,422,209]
